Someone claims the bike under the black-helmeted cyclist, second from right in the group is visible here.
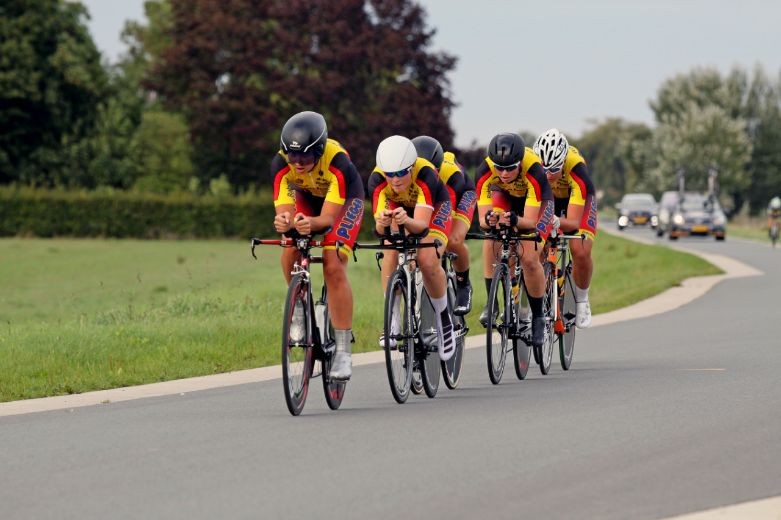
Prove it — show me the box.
[467,224,541,385]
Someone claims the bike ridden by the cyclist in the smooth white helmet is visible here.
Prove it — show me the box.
[354,227,465,404]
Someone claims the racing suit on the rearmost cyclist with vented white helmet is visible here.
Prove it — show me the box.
[551,145,597,240]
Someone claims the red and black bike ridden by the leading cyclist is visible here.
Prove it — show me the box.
[250,232,346,415]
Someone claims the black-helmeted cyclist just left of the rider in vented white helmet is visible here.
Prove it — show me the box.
[475,133,556,347]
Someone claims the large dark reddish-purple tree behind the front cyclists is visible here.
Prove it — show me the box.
[146,0,455,187]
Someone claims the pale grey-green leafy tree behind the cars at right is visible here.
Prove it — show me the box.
[651,66,781,211]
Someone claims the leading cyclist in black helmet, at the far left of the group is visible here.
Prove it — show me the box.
[271,111,364,380]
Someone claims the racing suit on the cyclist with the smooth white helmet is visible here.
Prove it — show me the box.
[369,157,452,245]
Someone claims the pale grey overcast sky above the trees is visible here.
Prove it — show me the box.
[77,0,781,146]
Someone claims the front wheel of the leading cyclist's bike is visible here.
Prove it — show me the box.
[282,275,314,415]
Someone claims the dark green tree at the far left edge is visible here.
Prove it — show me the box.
[0,0,108,185]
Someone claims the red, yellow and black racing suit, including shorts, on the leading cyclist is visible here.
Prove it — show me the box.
[271,139,364,255]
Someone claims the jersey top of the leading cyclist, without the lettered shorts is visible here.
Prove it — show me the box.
[271,139,364,207]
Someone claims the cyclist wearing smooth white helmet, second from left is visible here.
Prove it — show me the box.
[369,135,455,361]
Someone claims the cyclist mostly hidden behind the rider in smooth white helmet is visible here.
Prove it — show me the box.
[412,135,477,315]
